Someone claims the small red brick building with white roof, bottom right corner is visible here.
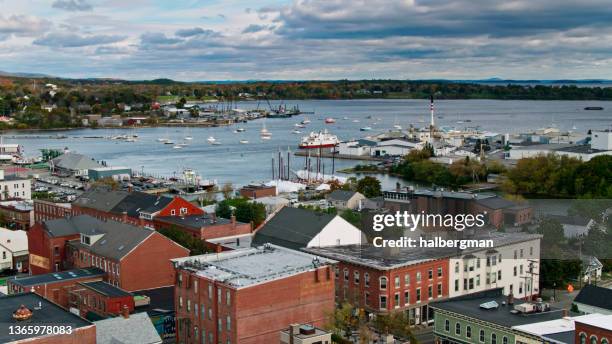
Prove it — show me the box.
[574,314,612,344]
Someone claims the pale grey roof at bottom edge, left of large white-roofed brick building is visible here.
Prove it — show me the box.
[94,312,162,344]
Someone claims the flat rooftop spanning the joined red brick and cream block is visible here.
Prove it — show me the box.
[303,232,541,270]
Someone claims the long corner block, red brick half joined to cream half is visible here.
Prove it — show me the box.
[304,232,541,325]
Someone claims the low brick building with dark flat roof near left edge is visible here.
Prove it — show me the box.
[6,268,105,309]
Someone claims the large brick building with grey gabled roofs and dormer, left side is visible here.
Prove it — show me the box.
[28,215,189,291]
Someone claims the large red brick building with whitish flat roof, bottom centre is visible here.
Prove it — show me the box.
[173,245,334,344]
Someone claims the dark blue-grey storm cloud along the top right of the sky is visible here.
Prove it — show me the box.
[274,0,612,39]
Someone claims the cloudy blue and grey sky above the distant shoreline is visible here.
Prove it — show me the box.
[0,0,612,81]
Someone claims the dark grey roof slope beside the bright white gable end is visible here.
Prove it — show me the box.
[252,207,336,249]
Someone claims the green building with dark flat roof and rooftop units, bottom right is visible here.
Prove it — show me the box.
[430,288,563,344]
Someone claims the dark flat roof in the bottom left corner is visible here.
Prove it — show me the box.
[0,293,93,343]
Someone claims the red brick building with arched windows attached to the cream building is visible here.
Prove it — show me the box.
[304,245,449,325]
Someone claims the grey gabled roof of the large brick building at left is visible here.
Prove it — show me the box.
[43,215,154,260]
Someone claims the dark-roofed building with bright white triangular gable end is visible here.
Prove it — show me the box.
[252,207,365,250]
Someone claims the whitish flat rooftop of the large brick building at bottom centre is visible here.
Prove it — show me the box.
[172,244,335,289]
